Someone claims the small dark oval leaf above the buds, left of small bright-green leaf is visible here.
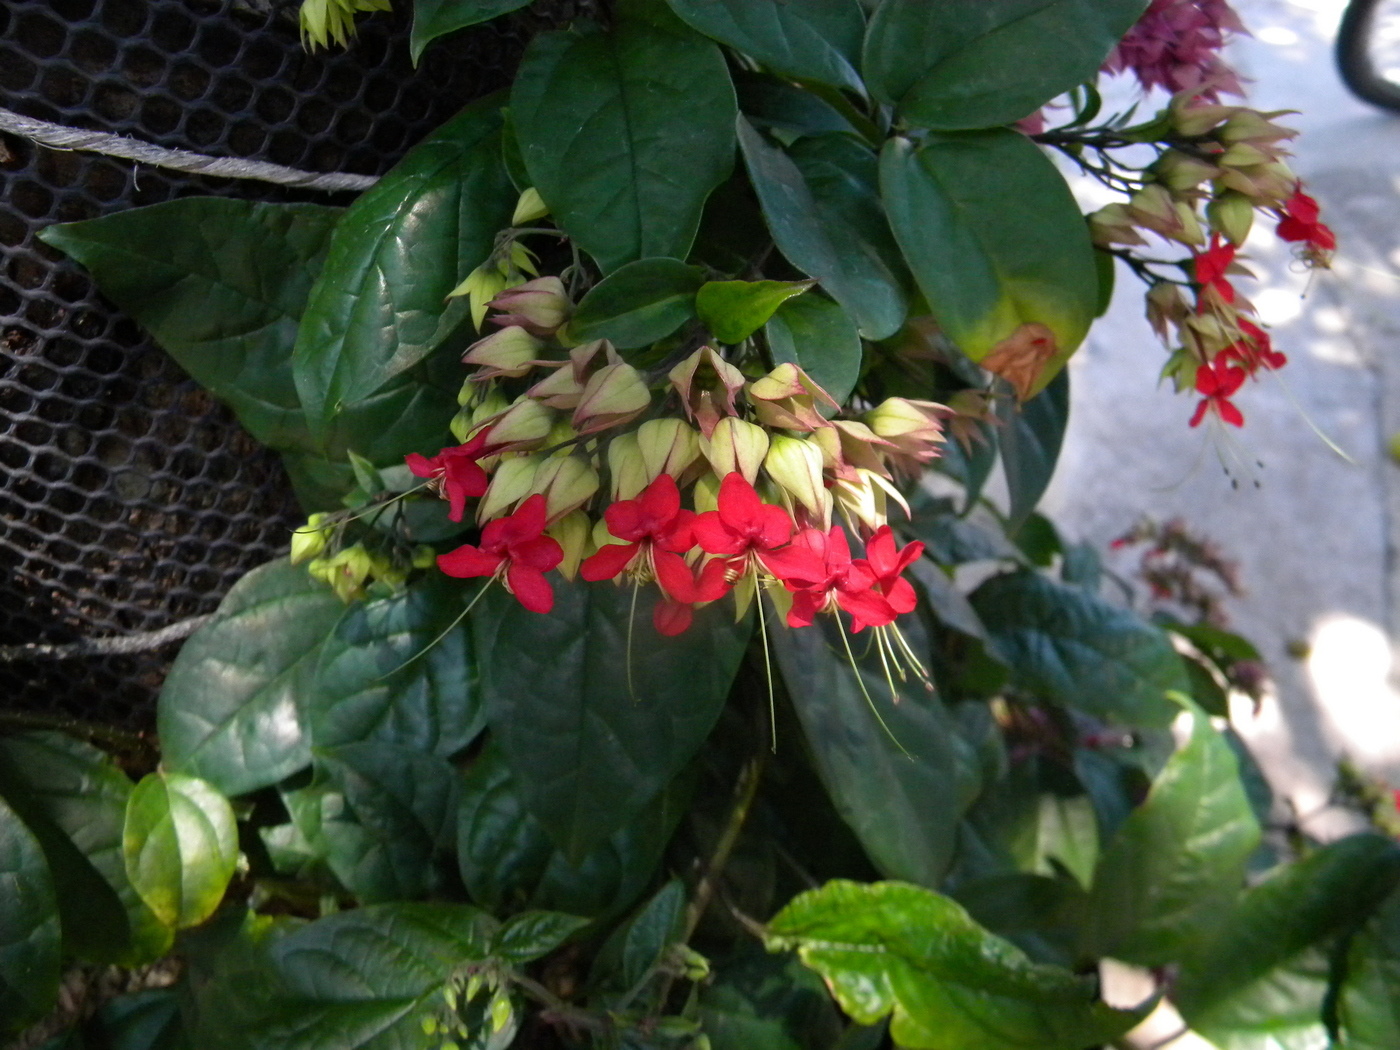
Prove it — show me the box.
[568,259,704,350]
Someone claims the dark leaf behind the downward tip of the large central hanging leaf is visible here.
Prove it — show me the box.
[456,745,685,916]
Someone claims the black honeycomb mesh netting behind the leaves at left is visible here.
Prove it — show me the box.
[0,0,573,728]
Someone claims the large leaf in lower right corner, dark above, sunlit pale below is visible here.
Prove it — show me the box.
[1173,834,1400,1050]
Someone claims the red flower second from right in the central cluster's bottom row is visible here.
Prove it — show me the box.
[759,525,895,633]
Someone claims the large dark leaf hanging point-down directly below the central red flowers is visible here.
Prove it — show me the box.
[473,581,749,862]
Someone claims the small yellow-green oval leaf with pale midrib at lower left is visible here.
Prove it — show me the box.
[122,773,238,930]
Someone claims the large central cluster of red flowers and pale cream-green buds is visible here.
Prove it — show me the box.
[394,271,949,634]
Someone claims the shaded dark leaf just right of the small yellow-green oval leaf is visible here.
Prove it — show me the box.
[315,741,458,902]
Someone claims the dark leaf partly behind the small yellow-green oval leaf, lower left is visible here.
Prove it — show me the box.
[0,732,171,965]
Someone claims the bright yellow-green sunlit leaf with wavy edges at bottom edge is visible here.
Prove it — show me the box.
[767,879,1145,1050]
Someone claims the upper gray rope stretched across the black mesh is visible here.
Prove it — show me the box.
[0,109,378,192]
